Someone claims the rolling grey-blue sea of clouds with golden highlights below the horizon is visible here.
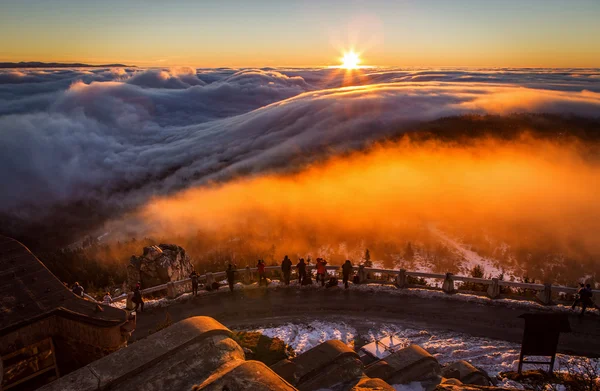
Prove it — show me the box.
[0,67,600,237]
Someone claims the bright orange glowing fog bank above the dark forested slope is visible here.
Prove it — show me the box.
[130,138,600,264]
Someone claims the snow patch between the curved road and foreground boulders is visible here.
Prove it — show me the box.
[246,321,600,391]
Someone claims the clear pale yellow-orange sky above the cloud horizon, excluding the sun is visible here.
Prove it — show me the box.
[0,0,600,67]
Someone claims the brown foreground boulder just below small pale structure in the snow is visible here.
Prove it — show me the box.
[365,345,442,390]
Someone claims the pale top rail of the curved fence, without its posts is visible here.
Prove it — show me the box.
[105,264,600,302]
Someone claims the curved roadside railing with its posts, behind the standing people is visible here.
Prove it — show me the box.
[94,265,600,305]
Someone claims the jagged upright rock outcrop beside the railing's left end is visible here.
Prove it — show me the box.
[127,244,193,288]
